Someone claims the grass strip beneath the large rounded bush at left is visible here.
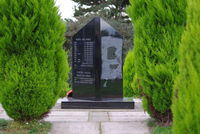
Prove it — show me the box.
[0,119,51,134]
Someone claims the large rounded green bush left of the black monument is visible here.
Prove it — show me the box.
[0,0,69,121]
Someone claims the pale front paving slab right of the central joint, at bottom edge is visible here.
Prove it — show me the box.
[101,122,149,134]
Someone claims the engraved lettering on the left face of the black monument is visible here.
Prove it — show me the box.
[73,38,95,84]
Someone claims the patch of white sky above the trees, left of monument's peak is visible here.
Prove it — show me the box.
[55,0,76,19]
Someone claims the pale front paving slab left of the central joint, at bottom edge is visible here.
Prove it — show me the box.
[50,122,100,134]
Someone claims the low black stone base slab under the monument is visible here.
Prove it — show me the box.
[61,98,135,109]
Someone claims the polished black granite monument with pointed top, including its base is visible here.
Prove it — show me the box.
[61,17,134,108]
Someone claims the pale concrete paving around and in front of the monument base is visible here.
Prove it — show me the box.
[0,99,150,134]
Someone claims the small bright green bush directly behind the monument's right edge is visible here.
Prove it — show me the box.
[123,50,142,97]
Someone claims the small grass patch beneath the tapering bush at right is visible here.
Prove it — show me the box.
[147,119,172,134]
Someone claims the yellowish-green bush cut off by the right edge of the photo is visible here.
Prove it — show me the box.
[172,0,200,134]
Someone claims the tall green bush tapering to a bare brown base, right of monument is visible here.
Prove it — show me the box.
[127,0,186,123]
